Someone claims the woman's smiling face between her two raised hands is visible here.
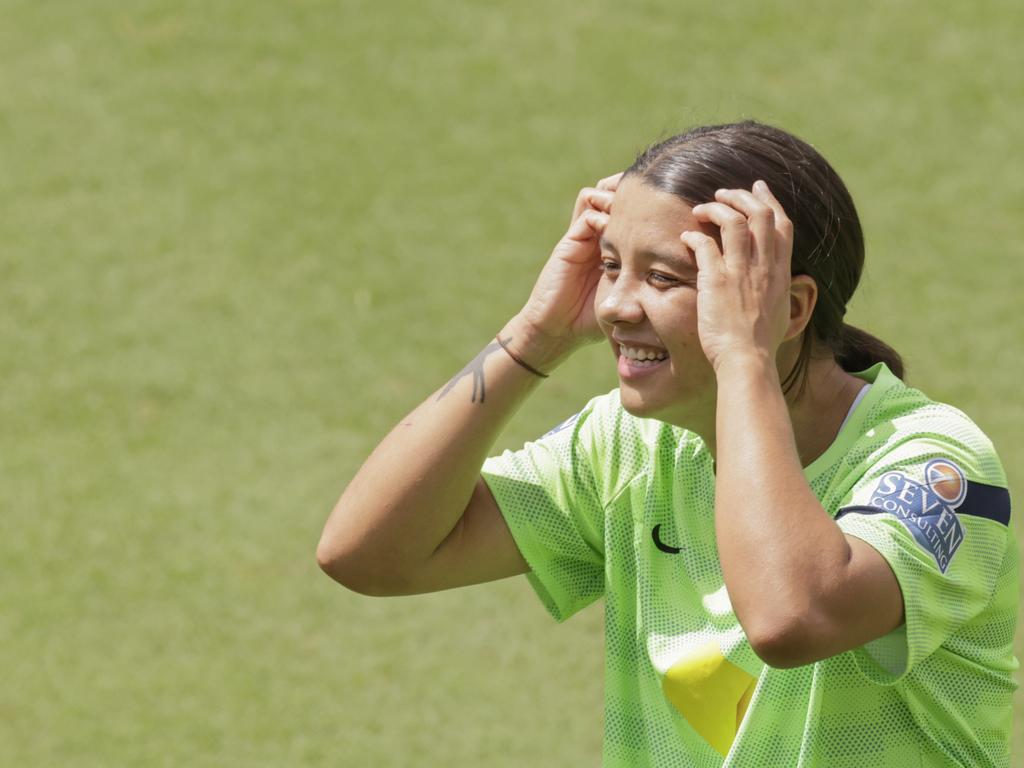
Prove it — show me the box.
[594,176,717,435]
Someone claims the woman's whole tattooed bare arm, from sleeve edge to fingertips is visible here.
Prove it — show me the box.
[316,174,622,594]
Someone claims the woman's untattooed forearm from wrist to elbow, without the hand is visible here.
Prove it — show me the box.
[715,355,851,643]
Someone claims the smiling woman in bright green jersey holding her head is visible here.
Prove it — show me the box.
[318,122,1017,768]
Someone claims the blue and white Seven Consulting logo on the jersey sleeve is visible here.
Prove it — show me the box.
[870,459,967,573]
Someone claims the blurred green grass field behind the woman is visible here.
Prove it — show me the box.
[0,0,1024,768]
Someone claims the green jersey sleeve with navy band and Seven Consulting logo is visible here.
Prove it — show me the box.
[837,432,1012,684]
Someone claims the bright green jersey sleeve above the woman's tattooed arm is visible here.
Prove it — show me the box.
[481,398,604,622]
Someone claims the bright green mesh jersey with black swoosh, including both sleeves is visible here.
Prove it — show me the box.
[482,364,1018,768]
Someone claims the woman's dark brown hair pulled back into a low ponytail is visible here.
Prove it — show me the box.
[626,121,903,392]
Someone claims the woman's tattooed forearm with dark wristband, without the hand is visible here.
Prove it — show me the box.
[317,318,555,589]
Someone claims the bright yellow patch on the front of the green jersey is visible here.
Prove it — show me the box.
[662,640,757,757]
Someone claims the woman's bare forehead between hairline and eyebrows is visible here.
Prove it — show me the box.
[605,176,700,250]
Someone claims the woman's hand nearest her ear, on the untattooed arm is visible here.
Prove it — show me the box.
[680,181,793,371]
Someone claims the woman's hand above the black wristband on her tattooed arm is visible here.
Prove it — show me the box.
[516,173,623,371]
